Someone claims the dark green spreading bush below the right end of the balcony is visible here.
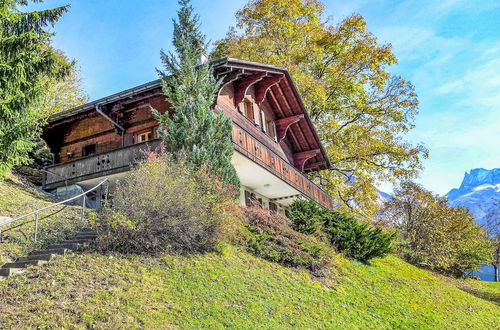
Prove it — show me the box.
[289,200,394,262]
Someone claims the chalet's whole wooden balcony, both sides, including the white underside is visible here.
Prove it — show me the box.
[44,126,332,208]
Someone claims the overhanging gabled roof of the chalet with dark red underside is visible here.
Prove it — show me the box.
[48,58,330,168]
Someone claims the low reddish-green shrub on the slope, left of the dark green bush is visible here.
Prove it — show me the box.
[243,207,330,271]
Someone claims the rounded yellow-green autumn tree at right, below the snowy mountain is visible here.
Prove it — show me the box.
[379,182,493,276]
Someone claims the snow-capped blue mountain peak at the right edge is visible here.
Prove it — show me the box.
[446,168,500,224]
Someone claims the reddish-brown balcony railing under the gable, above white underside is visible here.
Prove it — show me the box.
[232,122,332,208]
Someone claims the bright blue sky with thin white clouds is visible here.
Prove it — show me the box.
[30,0,500,194]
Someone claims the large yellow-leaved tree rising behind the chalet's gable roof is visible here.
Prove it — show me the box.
[214,0,427,213]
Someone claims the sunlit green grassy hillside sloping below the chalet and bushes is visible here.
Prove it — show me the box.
[0,175,500,329]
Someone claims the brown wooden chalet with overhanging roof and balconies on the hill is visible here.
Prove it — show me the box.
[43,58,332,212]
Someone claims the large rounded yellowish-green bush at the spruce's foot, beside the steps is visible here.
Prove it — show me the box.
[95,153,242,254]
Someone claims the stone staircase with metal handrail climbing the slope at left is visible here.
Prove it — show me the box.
[0,229,97,280]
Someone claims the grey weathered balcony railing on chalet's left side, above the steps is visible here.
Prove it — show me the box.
[44,140,161,189]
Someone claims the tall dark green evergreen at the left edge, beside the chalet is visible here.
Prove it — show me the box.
[0,0,71,176]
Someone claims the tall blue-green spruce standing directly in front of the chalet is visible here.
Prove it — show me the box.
[153,0,239,186]
